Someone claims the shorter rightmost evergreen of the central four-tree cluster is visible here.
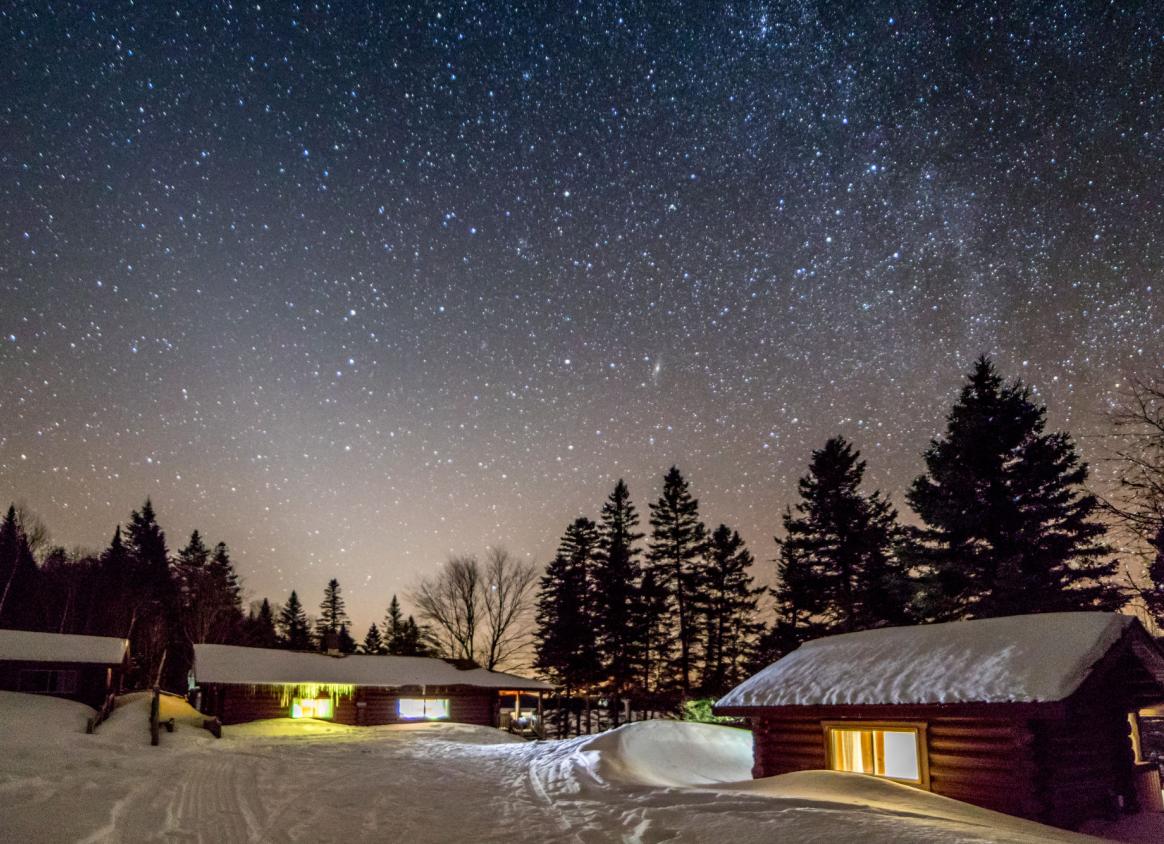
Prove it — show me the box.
[698,525,764,696]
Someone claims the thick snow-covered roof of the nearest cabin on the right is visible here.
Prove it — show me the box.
[716,612,1150,709]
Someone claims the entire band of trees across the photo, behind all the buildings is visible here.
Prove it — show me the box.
[0,357,1164,724]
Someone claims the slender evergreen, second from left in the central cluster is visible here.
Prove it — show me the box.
[594,480,644,726]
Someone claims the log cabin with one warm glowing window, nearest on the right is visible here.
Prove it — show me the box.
[714,612,1164,828]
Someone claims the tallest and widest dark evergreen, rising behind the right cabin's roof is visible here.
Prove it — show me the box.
[907,357,1123,620]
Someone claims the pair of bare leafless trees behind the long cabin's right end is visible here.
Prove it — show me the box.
[407,548,538,671]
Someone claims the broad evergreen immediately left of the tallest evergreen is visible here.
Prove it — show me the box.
[776,437,910,646]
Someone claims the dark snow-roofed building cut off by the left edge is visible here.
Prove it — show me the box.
[0,630,129,709]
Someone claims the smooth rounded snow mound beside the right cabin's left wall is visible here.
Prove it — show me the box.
[579,721,752,786]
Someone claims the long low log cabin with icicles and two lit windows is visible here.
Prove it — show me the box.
[193,645,553,726]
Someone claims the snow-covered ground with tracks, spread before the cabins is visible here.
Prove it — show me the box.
[0,691,1136,844]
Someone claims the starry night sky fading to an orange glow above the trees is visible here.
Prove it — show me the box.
[0,0,1164,630]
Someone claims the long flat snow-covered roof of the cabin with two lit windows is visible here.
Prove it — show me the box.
[194,645,553,691]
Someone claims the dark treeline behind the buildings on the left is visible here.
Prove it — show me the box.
[0,499,434,690]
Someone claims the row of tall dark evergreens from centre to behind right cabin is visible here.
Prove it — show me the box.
[535,359,1136,718]
